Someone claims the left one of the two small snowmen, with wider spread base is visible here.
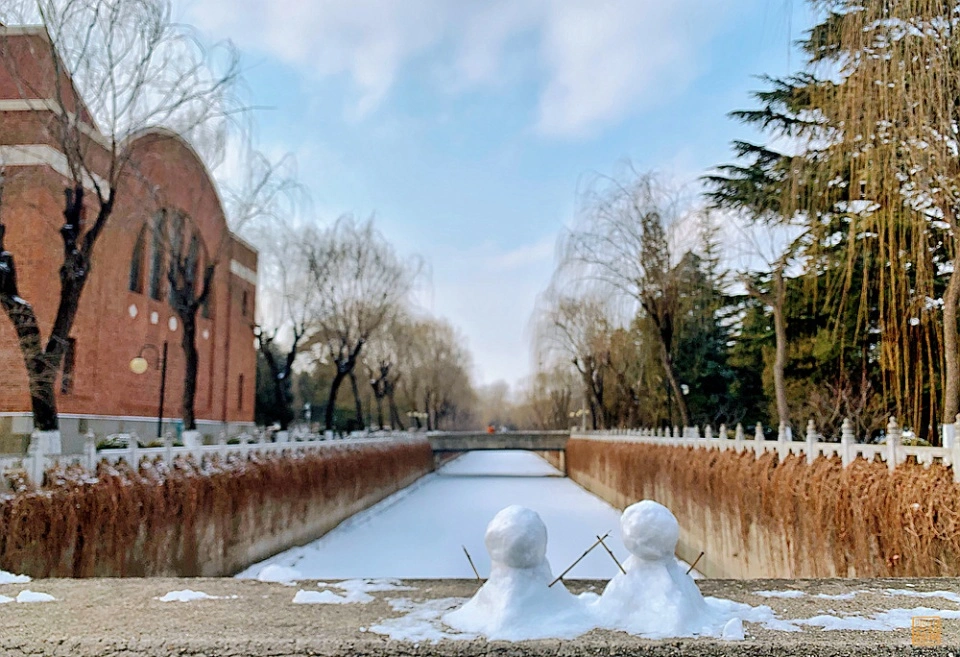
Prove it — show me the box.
[443,505,593,641]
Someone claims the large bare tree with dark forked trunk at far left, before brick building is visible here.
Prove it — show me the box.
[0,0,238,431]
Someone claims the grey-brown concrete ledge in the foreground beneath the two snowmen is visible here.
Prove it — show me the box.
[0,578,960,657]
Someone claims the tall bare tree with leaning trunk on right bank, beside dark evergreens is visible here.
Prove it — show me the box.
[559,171,690,426]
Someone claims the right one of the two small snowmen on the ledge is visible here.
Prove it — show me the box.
[594,500,722,637]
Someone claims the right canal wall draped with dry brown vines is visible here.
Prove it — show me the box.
[566,438,960,578]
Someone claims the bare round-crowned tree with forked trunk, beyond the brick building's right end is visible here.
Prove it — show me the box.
[304,216,419,429]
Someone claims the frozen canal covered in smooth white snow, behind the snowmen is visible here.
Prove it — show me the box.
[238,452,627,580]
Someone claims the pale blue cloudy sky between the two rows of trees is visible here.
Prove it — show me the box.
[177,0,811,385]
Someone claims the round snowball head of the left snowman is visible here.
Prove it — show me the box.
[483,504,547,568]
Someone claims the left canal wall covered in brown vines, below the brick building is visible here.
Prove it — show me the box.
[0,438,433,577]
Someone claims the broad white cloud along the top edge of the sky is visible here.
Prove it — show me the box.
[188,0,741,136]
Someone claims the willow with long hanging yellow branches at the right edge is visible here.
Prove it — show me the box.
[797,0,960,440]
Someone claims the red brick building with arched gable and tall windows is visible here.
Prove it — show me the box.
[0,26,257,453]
